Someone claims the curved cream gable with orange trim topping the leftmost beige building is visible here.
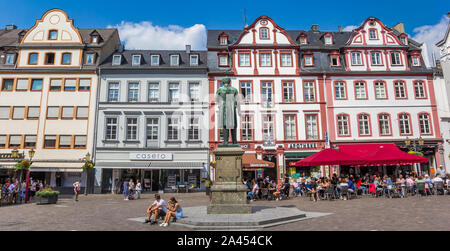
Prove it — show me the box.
[21,9,82,44]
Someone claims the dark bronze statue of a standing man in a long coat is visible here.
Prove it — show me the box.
[215,77,241,146]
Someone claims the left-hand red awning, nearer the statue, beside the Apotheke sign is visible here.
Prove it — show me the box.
[295,148,366,166]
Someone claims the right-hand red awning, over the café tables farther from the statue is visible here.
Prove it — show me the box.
[338,144,428,166]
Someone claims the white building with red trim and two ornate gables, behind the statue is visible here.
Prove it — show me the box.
[207,16,442,179]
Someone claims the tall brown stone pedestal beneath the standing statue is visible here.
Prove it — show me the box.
[207,146,252,214]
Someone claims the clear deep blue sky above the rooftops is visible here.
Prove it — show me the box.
[0,0,450,58]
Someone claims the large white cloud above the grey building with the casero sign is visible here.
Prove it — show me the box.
[110,21,206,50]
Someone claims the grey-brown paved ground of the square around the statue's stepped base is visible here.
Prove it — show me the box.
[0,193,450,231]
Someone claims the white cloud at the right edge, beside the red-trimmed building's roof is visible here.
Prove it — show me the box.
[412,16,450,60]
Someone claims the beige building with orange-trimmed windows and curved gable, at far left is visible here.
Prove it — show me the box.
[0,9,120,191]
